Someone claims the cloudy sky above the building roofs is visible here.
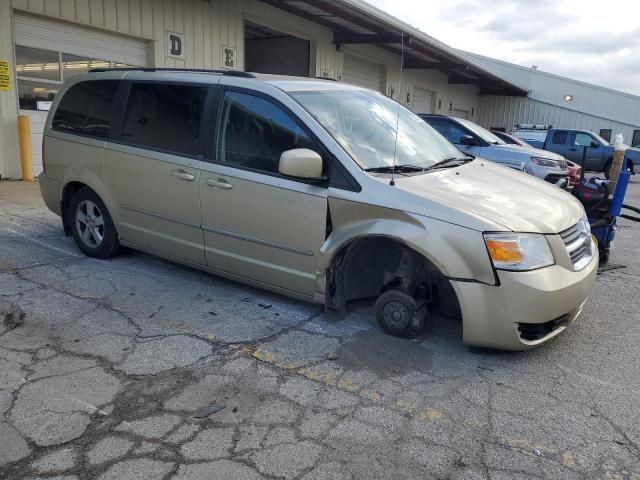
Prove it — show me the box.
[368,0,640,95]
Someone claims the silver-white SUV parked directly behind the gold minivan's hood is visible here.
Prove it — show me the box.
[420,114,569,188]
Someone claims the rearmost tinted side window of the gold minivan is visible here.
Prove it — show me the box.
[51,80,120,138]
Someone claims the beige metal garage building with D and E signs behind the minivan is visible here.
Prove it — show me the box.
[0,0,527,178]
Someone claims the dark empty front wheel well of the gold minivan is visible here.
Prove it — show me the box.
[326,236,460,316]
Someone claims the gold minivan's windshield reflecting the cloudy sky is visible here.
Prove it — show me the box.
[290,90,465,171]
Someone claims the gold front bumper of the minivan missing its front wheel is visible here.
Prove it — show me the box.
[452,249,599,350]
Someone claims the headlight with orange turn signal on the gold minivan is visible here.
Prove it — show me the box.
[484,233,555,271]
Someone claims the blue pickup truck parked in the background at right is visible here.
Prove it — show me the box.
[512,126,640,178]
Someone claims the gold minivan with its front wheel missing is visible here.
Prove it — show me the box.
[40,69,598,350]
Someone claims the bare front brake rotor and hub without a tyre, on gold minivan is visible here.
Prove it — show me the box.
[375,290,427,337]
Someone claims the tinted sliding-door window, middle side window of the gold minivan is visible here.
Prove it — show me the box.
[122,83,207,156]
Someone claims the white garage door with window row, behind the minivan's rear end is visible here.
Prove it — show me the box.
[14,15,147,175]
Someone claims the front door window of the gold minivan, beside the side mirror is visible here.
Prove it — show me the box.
[217,91,320,173]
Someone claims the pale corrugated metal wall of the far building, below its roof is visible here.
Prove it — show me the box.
[479,95,640,144]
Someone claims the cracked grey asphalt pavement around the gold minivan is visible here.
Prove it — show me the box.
[0,179,640,480]
